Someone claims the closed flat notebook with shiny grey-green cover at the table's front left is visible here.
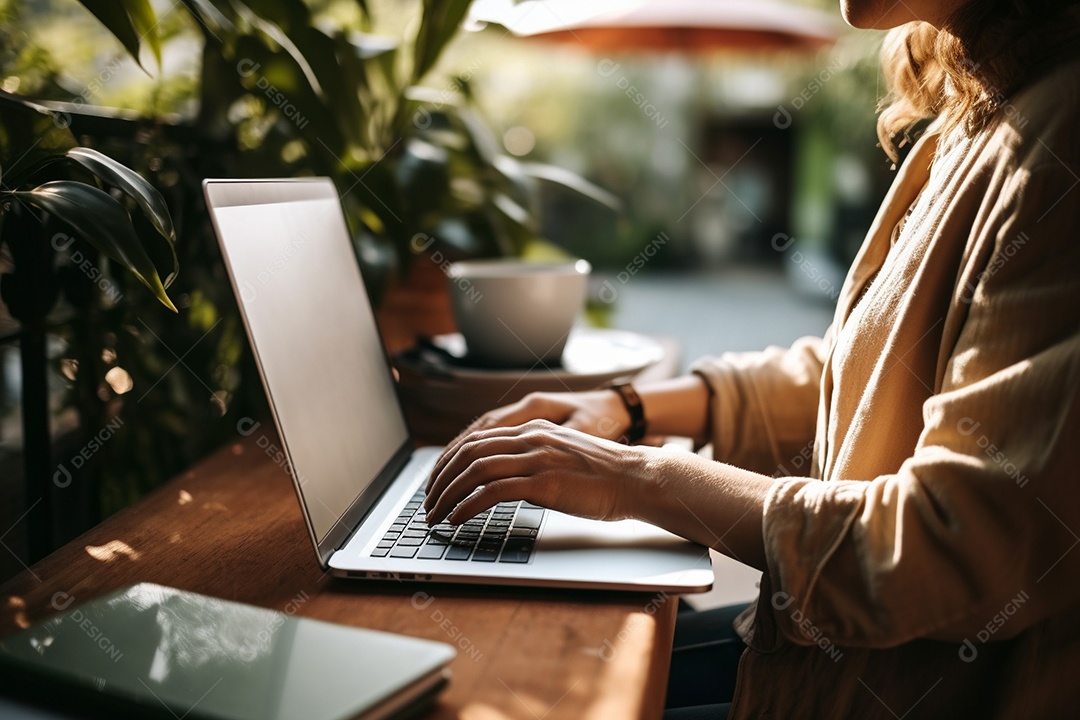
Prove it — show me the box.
[0,583,456,720]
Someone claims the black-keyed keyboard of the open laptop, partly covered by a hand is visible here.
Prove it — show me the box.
[372,490,544,562]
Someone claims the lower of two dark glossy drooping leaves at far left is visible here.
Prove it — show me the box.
[12,180,176,312]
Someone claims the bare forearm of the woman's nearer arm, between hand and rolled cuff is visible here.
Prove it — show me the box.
[626,448,775,570]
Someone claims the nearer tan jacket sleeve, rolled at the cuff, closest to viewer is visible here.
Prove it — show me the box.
[755,161,1080,649]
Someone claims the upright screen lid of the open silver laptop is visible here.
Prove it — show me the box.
[203,178,410,566]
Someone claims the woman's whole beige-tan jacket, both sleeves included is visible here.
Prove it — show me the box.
[694,53,1080,720]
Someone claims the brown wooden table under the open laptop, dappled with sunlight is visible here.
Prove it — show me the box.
[0,436,676,720]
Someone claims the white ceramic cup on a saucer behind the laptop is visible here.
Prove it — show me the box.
[447,258,592,367]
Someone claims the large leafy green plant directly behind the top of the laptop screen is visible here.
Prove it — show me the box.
[63,0,618,282]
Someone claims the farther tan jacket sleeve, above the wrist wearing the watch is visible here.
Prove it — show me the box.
[690,331,832,476]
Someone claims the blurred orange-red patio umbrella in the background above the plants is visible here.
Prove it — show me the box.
[469,0,839,53]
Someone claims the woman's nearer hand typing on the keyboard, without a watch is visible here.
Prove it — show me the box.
[426,416,650,525]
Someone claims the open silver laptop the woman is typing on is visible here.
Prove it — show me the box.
[203,178,713,593]
